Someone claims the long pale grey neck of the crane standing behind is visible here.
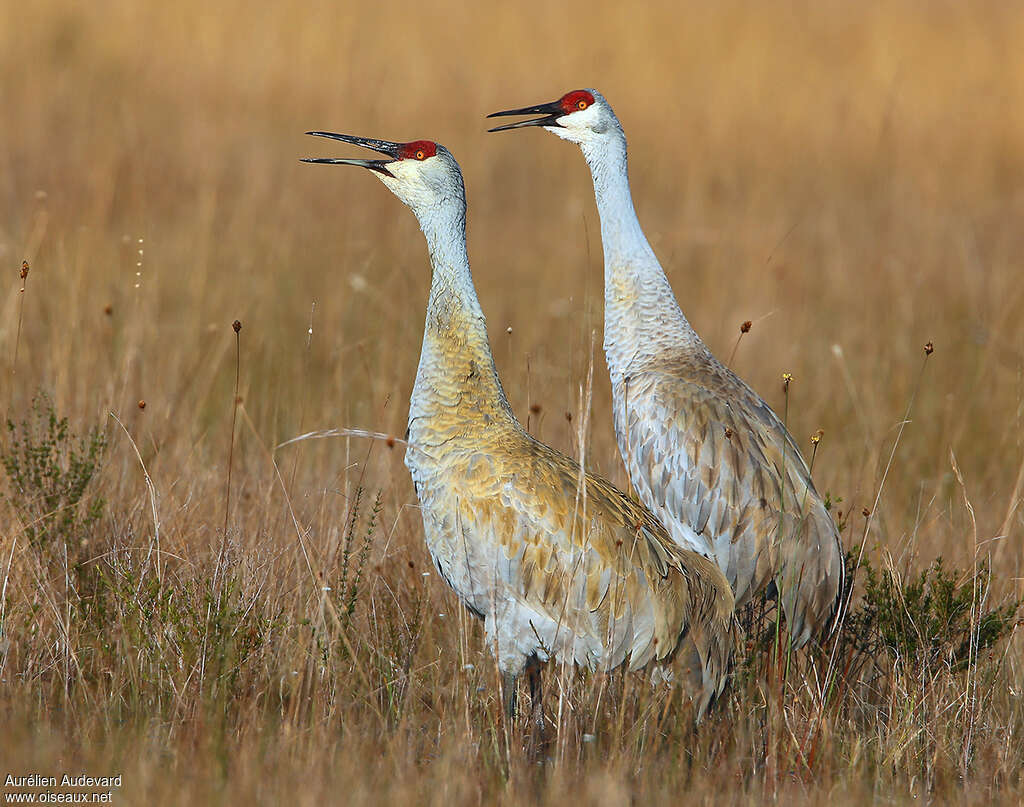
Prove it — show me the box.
[582,132,706,381]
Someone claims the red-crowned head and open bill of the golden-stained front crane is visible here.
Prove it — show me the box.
[302,132,466,220]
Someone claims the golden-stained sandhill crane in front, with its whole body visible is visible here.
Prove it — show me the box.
[305,132,735,731]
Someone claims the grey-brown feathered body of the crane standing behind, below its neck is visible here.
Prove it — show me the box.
[615,367,843,643]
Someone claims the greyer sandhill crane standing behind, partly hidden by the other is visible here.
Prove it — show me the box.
[488,89,844,646]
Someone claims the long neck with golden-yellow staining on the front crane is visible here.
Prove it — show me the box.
[409,204,512,445]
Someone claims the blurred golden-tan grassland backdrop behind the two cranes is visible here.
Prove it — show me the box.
[0,0,1024,798]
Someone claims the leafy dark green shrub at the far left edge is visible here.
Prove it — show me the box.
[0,393,106,548]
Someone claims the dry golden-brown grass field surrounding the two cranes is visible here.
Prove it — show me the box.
[0,0,1024,807]
